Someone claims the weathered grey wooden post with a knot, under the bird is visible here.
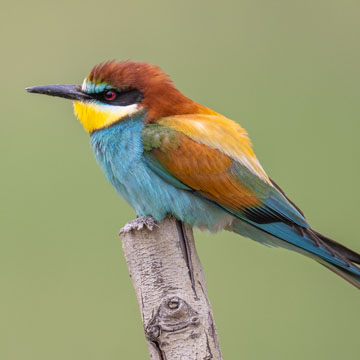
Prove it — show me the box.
[120,217,222,360]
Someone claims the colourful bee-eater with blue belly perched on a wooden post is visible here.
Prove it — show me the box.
[26,60,360,289]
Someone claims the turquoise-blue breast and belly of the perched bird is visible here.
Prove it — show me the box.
[91,118,232,231]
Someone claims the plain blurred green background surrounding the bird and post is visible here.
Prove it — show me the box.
[0,0,360,360]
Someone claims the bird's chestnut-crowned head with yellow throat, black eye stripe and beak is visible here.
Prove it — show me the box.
[28,61,214,133]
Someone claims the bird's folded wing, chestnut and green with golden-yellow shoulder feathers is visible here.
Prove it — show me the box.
[143,115,308,227]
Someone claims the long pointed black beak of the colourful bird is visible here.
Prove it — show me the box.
[26,85,92,101]
